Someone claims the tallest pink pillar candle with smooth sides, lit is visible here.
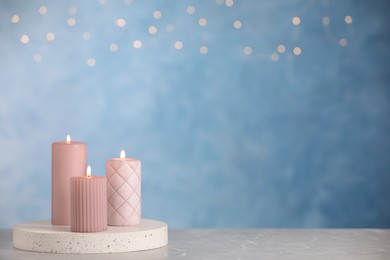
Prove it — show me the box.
[51,135,87,226]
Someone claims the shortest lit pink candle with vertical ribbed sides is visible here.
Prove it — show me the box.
[70,166,107,232]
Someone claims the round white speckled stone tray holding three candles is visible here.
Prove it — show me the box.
[13,219,168,254]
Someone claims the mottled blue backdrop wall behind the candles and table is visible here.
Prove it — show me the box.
[0,0,390,228]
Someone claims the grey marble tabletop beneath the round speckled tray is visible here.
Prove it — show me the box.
[0,229,390,260]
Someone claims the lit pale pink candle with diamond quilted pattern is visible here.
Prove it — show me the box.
[106,150,141,226]
